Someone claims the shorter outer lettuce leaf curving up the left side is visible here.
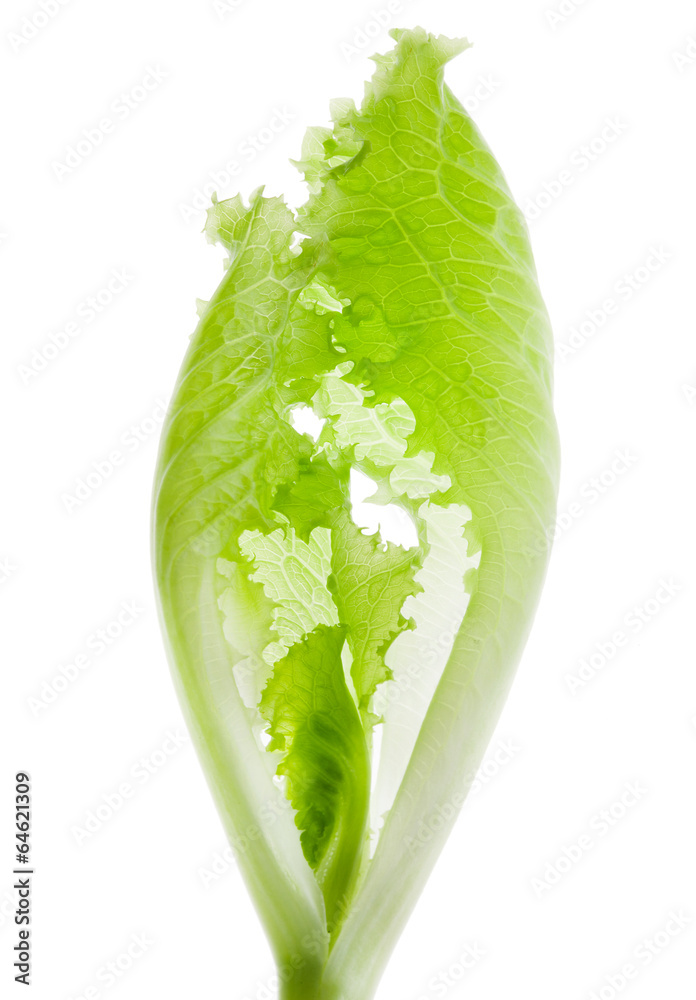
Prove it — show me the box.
[154,194,339,972]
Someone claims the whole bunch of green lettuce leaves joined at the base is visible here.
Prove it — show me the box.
[154,28,559,1000]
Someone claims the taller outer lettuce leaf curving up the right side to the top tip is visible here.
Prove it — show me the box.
[292,29,558,997]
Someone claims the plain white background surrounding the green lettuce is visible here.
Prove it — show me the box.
[0,0,696,1000]
